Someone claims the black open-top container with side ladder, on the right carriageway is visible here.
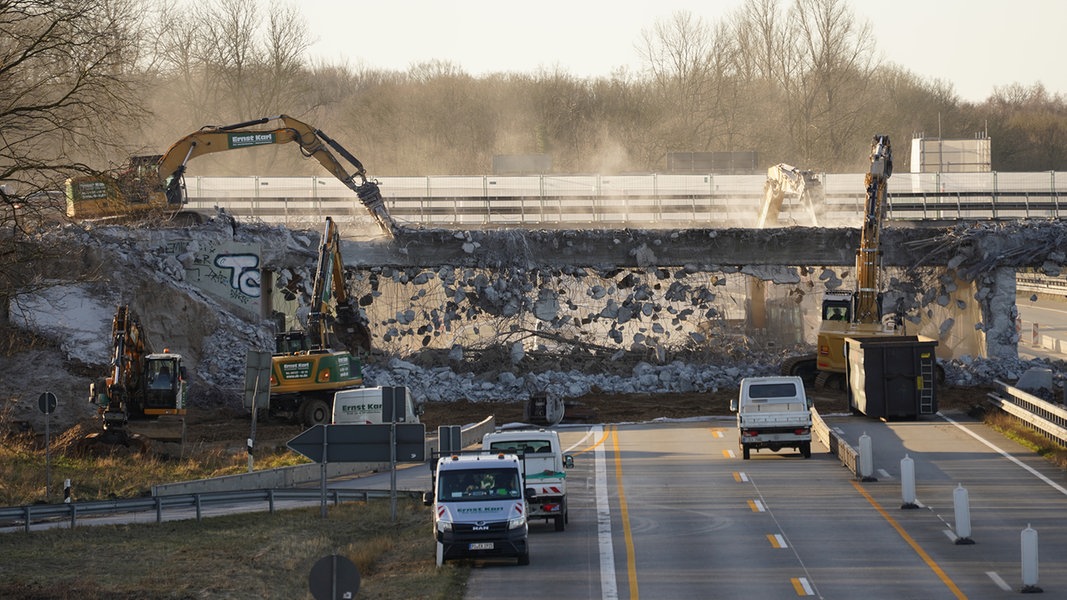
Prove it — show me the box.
[845,335,937,420]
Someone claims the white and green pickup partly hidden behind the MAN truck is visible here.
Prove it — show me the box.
[481,429,574,532]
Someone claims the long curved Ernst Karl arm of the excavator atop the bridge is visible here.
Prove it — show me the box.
[159,114,398,237]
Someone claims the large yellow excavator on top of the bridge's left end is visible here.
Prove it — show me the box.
[66,114,397,236]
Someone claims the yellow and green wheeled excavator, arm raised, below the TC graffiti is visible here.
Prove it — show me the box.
[268,217,370,427]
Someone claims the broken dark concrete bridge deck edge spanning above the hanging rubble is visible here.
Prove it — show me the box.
[343,221,1067,275]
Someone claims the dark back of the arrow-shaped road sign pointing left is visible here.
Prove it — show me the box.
[285,423,426,462]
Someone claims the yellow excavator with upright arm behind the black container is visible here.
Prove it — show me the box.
[782,135,905,388]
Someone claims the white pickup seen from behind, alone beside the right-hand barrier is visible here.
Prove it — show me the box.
[730,377,811,460]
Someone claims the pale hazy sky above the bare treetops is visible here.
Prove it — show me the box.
[292,0,1067,100]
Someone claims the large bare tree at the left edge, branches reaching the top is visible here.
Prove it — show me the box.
[0,0,149,319]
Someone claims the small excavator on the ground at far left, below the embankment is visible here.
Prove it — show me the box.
[79,305,189,454]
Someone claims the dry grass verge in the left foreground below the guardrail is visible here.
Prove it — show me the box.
[0,500,469,600]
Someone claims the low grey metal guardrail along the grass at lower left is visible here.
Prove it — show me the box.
[0,488,421,532]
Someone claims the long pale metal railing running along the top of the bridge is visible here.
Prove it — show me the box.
[187,172,1067,227]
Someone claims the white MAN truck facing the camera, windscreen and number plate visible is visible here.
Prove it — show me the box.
[423,453,530,567]
